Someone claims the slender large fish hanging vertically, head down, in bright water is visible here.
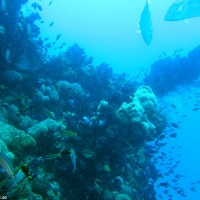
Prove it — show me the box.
[139,0,153,45]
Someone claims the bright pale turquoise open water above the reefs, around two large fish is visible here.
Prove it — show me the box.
[22,0,200,76]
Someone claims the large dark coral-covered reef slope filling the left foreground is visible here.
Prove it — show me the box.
[0,0,165,200]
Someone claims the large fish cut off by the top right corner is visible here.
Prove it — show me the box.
[164,0,200,21]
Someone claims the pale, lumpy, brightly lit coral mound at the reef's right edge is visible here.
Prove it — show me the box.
[116,86,157,138]
